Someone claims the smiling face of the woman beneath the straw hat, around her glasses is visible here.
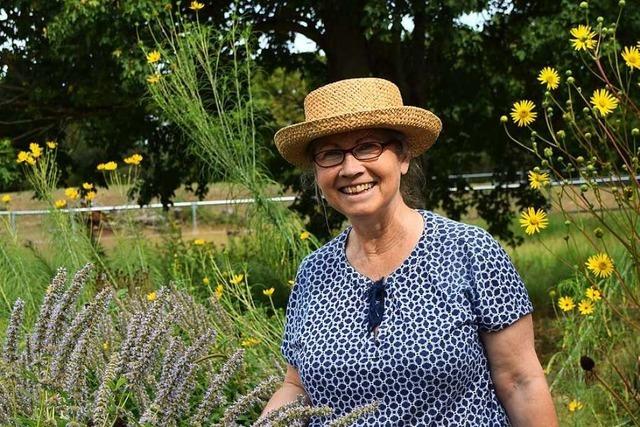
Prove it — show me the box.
[312,129,410,219]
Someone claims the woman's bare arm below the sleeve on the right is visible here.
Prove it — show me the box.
[480,314,558,427]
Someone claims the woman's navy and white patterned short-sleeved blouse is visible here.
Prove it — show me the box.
[282,211,533,427]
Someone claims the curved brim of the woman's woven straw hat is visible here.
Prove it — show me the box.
[274,106,442,169]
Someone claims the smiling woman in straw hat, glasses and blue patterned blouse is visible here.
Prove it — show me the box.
[263,78,557,427]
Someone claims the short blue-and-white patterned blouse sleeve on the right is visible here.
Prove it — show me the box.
[467,229,533,332]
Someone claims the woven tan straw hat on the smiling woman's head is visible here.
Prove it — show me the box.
[274,78,442,168]
